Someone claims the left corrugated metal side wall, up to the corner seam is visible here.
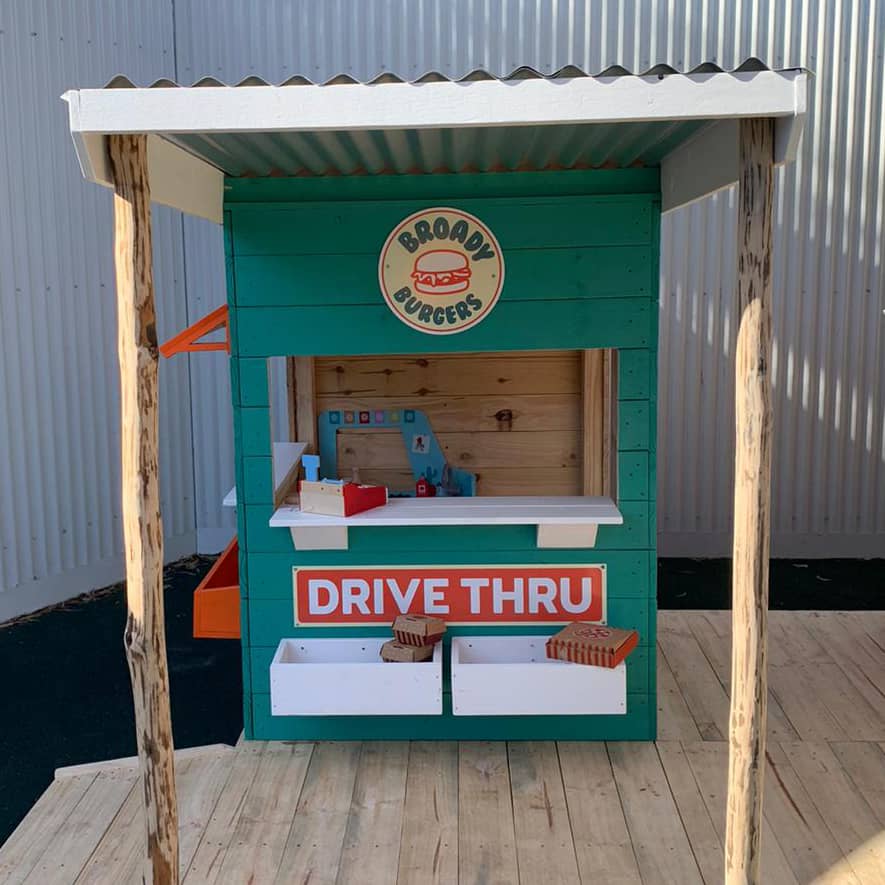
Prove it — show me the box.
[0,0,194,621]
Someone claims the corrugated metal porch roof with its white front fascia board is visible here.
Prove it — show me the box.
[65,57,803,180]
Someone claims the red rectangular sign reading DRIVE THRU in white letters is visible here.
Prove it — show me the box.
[293,565,606,626]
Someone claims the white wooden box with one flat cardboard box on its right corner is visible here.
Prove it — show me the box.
[452,636,627,716]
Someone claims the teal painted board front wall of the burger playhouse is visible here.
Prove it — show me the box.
[225,169,660,740]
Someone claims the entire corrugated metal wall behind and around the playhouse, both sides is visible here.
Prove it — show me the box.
[0,0,885,620]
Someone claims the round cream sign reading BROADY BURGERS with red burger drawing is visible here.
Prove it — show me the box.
[378,208,504,335]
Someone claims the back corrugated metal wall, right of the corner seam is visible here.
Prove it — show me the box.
[176,0,885,556]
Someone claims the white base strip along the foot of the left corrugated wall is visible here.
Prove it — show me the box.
[0,532,196,623]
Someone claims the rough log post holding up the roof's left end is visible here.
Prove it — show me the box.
[109,135,178,885]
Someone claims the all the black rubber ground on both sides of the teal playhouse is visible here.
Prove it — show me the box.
[0,557,885,843]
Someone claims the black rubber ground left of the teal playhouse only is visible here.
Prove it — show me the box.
[0,557,243,843]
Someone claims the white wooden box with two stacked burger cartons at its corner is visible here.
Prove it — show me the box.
[270,637,442,716]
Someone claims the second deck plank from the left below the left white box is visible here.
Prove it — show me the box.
[276,741,362,885]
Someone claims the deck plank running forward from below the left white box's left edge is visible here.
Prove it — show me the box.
[217,743,313,885]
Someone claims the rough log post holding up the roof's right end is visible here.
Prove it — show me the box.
[725,119,774,885]
